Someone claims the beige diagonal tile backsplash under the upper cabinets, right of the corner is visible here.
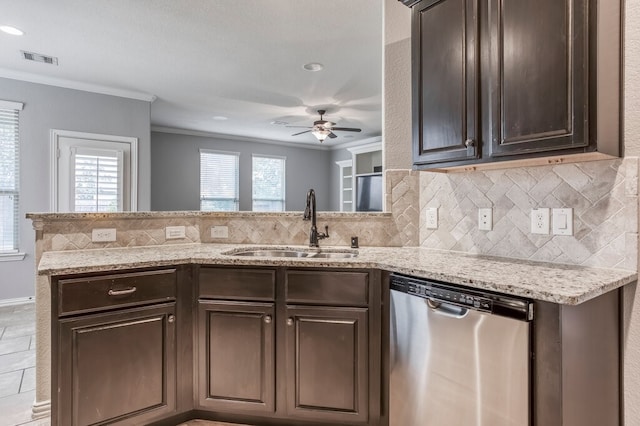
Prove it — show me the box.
[419,157,638,270]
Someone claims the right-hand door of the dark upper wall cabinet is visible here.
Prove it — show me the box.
[482,0,589,158]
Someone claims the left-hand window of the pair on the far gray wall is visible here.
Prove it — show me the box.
[200,149,240,212]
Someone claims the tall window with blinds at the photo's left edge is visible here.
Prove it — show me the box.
[0,101,22,253]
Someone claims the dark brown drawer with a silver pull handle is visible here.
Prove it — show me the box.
[58,269,176,316]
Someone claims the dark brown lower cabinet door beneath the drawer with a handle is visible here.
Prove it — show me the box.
[54,303,176,426]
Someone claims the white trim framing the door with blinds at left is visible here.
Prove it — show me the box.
[49,129,138,212]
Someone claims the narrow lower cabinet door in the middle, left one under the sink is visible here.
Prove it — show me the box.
[198,300,275,412]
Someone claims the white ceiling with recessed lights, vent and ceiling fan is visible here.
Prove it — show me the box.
[0,0,383,145]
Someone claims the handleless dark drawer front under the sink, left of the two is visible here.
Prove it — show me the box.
[198,268,276,300]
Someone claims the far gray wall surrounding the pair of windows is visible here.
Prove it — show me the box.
[151,132,335,211]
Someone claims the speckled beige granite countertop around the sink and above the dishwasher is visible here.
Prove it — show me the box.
[38,243,637,305]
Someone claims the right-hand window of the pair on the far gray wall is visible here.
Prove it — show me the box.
[251,155,286,212]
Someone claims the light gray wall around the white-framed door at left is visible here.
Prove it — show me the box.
[0,78,151,300]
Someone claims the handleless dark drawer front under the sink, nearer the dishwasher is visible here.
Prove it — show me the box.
[286,270,369,306]
